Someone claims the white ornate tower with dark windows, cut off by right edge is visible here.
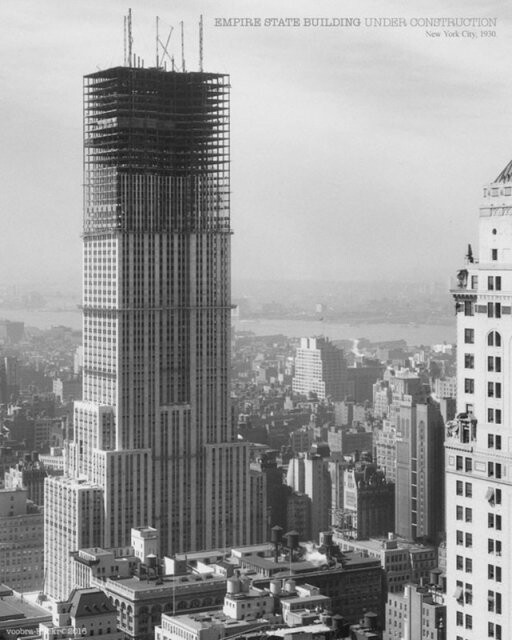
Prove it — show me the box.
[445,162,512,640]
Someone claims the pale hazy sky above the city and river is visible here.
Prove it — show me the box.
[0,0,512,287]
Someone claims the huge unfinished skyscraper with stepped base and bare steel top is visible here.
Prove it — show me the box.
[45,60,254,598]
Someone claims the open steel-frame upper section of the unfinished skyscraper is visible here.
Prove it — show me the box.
[84,67,230,236]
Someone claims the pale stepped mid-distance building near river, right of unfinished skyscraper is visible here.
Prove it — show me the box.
[292,338,347,400]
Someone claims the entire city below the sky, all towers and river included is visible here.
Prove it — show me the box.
[0,5,512,640]
